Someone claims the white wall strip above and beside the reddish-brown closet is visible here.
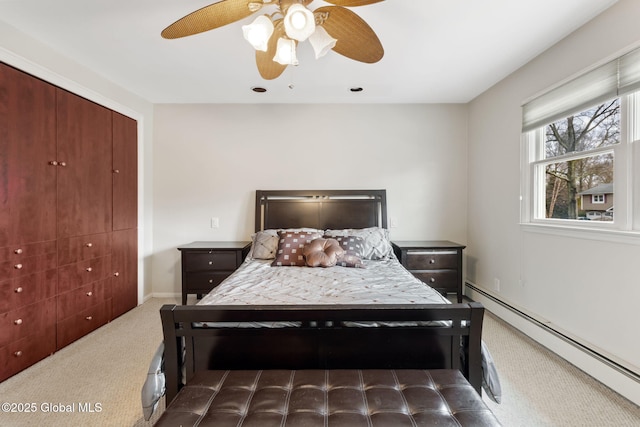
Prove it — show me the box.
[0,21,153,303]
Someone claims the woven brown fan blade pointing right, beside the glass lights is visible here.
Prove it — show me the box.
[314,6,384,64]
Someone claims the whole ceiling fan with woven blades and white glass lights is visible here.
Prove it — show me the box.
[161,0,384,80]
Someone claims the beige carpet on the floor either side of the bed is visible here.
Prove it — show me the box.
[0,299,640,427]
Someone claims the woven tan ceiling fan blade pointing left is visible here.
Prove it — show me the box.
[160,0,256,39]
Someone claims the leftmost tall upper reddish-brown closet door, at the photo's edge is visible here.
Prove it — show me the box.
[0,64,57,247]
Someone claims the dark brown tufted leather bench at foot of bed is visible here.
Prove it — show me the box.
[156,369,500,427]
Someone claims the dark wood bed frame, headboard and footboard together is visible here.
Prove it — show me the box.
[160,190,484,404]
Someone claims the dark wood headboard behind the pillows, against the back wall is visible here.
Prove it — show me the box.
[255,190,387,231]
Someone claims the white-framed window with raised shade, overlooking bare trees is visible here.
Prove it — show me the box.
[521,49,640,231]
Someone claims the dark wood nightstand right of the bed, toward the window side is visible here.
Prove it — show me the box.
[393,240,465,302]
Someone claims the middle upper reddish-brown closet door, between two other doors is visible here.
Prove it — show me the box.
[57,89,113,238]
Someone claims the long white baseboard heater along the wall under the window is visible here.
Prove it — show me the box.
[465,282,640,405]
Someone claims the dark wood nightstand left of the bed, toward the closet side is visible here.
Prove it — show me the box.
[178,242,251,305]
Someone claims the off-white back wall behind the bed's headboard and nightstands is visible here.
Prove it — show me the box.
[153,104,467,295]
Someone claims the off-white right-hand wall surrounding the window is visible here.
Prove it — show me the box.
[466,0,640,403]
